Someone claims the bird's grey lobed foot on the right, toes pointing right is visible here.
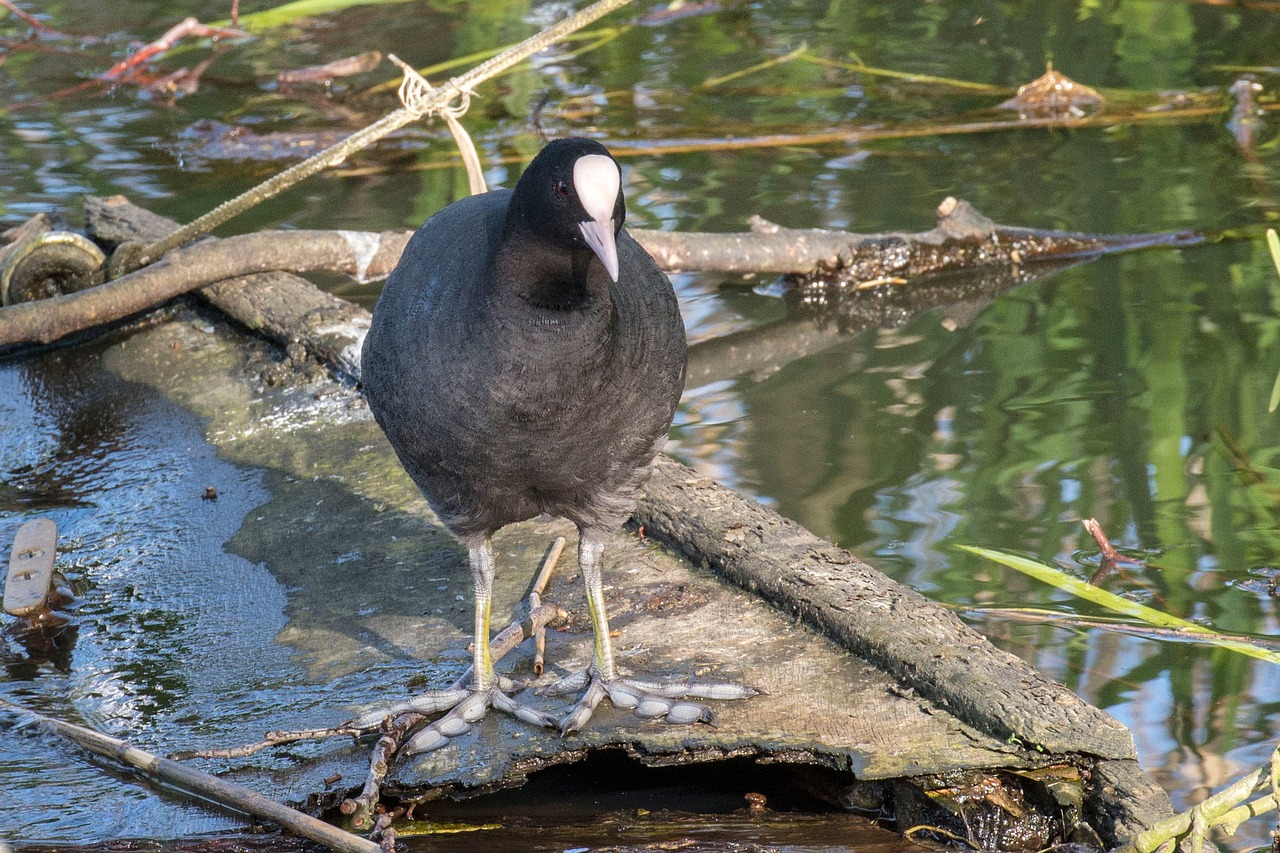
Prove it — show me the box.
[543,666,760,734]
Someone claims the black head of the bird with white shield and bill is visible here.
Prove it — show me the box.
[507,138,627,282]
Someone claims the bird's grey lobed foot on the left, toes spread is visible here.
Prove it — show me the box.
[352,676,559,756]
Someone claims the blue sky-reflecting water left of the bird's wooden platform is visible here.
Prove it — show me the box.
[0,347,278,840]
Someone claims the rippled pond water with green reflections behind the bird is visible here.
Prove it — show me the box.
[0,0,1280,849]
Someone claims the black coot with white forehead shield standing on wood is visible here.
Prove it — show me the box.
[362,140,755,752]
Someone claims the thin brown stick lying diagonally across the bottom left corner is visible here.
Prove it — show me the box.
[0,699,381,853]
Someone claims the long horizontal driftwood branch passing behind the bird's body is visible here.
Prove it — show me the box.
[0,199,1202,357]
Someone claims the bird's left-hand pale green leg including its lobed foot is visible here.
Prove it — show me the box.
[358,539,557,754]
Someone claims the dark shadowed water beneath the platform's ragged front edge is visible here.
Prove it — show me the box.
[22,751,923,853]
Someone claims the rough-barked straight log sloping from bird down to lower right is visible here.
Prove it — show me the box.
[82,195,1169,839]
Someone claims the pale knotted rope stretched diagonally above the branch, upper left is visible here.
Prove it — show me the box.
[119,0,631,273]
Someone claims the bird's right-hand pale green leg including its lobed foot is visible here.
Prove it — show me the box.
[556,530,758,734]
